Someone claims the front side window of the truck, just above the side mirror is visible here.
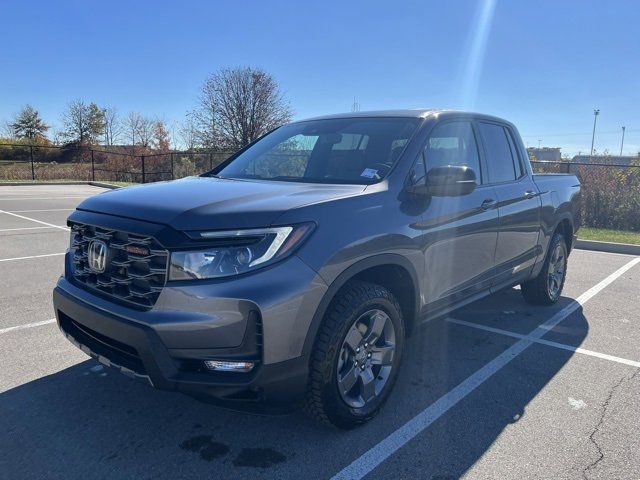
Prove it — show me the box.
[424,122,480,183]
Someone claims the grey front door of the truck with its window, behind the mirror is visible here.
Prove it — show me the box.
[422,119,498,310]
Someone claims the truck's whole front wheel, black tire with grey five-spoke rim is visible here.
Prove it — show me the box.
[305,282,404,428]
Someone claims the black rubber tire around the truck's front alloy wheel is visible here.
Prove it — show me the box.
[305,281,405,429]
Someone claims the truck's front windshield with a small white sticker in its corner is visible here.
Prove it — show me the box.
[212,117,419,185]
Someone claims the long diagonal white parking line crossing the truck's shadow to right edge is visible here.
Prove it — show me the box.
[332,258,640,480]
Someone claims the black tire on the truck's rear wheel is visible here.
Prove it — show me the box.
[520,233,568,305]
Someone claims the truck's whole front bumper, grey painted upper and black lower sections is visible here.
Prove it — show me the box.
[53,253,325,411]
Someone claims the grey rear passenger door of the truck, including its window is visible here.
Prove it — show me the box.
[477,121,540,286]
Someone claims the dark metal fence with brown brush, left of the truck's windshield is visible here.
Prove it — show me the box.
[0,143,233,183]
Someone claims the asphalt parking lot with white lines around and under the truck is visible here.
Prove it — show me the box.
[0,185,640,480]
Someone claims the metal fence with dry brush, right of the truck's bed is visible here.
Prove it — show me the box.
[531,159,640,231]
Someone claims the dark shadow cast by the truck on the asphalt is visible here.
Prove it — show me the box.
[0,289,588,479]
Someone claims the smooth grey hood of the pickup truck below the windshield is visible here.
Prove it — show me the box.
[78,177,365,230]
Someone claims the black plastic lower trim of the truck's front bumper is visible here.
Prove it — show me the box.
[53,286,308,410]
